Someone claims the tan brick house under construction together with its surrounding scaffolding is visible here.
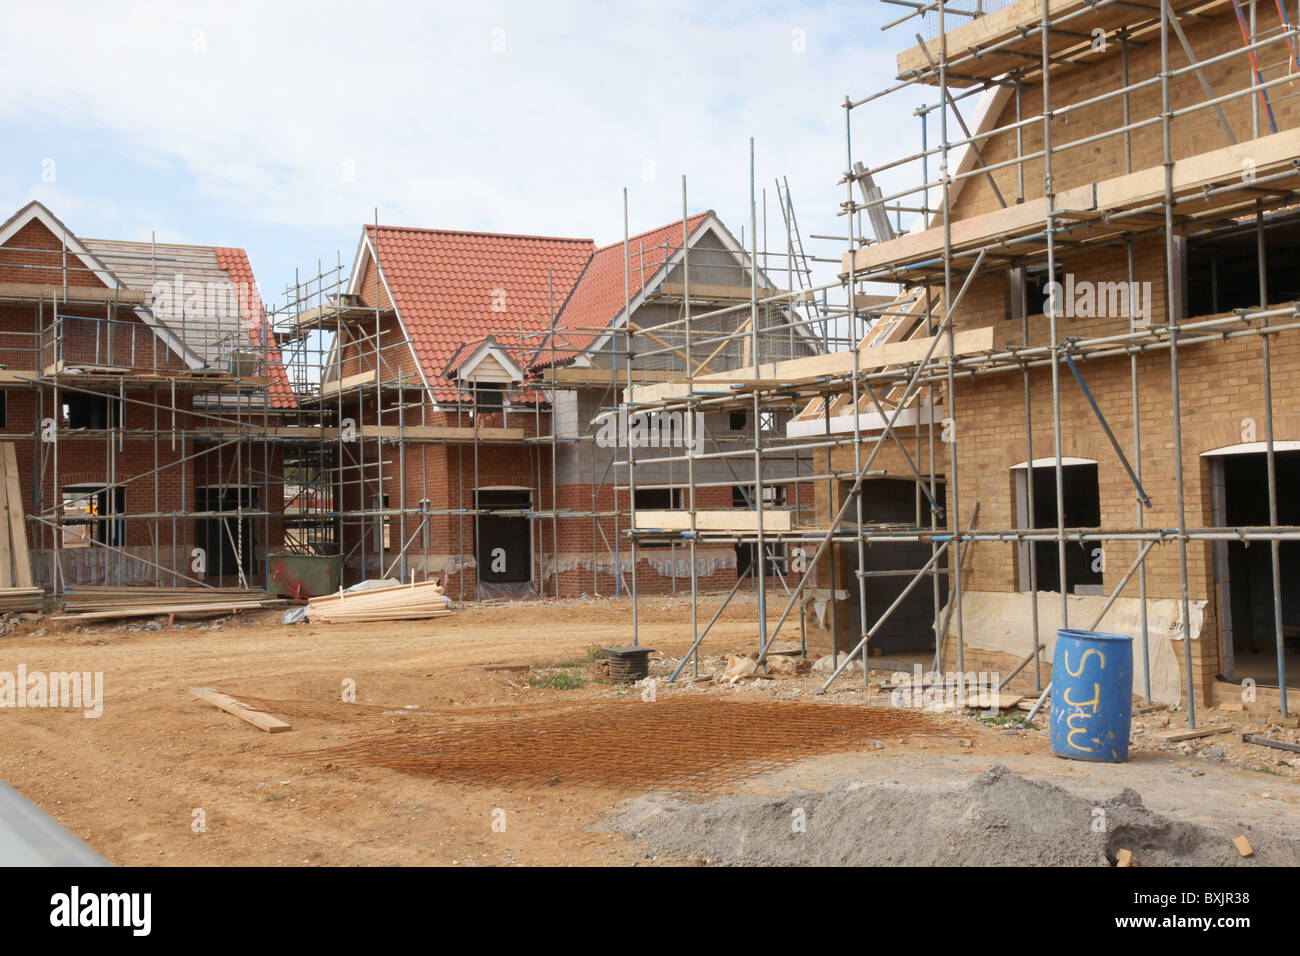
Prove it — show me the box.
[608,0,1300,726]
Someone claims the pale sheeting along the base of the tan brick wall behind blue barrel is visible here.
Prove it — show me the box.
[944,591,1205,704]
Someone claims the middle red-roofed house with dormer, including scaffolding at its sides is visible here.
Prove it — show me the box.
[276,211,827,600]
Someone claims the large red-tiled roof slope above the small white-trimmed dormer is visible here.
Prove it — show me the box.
[365,225,595,401]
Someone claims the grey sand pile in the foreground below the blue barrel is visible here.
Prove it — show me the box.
[608,766,1300,866]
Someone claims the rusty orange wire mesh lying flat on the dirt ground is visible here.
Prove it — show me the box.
[300,697,939,792]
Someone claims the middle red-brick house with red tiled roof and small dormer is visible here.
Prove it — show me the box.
[320,212,814,598]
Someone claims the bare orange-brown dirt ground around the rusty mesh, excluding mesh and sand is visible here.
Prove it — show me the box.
[0,596,1300,865]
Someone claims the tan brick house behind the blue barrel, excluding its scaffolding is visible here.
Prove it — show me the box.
[792,0,1300,704]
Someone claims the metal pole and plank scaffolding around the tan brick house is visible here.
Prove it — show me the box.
[608,0,1300,727]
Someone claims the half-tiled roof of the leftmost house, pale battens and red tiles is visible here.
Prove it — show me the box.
[83,239,296,408]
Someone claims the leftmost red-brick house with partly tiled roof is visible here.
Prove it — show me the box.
[0,202,295,591]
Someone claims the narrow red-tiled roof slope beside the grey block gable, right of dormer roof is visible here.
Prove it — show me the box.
[529,209,712,367]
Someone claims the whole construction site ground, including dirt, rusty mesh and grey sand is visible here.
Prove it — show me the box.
[0,594,1300,865]
